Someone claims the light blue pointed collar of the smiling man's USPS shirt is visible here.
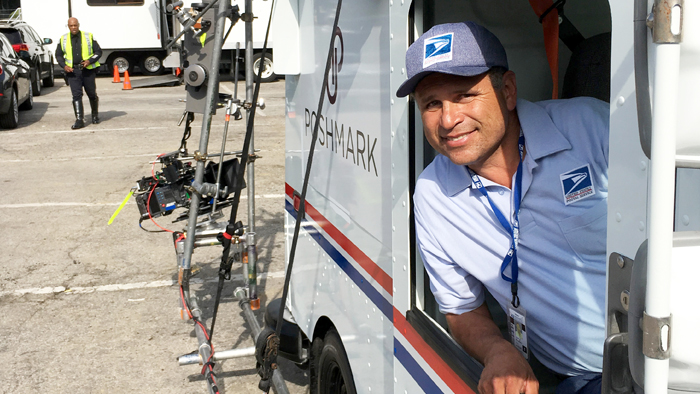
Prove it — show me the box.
[442,99,571,196]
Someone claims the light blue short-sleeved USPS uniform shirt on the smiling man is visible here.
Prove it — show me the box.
[414,98,609,375]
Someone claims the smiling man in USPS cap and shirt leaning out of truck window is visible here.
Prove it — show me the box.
[397,22,609,394]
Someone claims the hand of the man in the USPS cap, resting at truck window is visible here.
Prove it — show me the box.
[479,341,540,394]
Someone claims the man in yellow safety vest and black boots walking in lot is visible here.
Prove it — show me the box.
[56,18,102,129]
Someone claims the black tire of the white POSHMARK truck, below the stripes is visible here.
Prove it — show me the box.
[310,330,357,394]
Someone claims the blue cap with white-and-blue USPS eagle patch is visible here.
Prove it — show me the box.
[396,22,508,97]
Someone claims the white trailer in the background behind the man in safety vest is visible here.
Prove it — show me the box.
[22,0,274,79]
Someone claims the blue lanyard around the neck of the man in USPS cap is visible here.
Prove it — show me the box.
[467,134,525,308]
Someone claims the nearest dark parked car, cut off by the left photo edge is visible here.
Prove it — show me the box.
[0,34,34,129]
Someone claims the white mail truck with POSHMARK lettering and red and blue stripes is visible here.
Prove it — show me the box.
[275,0,700,394]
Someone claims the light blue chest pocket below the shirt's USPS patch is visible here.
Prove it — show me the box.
[559,202,608,262]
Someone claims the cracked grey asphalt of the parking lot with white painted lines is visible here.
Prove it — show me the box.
[0,77,308,394]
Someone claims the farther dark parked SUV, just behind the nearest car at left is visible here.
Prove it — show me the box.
[0,20,54,96]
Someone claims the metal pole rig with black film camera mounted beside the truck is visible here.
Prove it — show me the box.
[123,0,288,394]
